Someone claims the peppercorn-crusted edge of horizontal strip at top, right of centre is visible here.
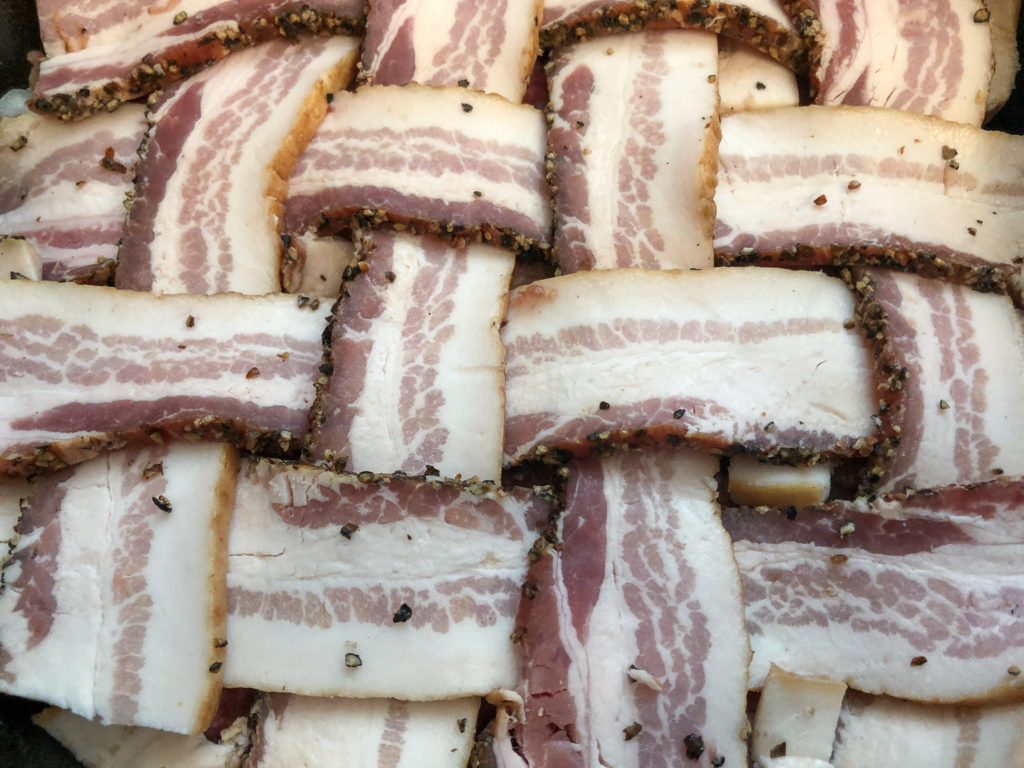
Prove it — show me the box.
[540,0,820,74]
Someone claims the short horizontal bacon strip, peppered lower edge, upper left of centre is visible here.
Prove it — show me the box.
[285,84,551,249]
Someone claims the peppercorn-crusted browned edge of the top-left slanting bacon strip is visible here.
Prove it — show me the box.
[28,4,366,121]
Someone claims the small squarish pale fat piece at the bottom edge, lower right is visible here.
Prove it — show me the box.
[751,666,846,768]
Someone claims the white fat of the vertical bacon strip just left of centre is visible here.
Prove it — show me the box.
[346,236,515,480]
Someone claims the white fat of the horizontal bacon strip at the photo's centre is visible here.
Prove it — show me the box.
[503,267,874,448]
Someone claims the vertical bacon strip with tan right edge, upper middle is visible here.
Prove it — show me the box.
[547,30,718,273]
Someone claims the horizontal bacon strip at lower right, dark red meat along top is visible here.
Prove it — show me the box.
[723,482,1024,701]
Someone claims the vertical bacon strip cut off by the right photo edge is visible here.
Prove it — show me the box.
[866,269,1024,492]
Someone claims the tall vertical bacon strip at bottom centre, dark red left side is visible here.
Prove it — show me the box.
[517,447,750,768]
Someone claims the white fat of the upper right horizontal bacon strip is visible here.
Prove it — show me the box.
[715,105,1024,263]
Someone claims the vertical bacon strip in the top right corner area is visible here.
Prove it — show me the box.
[809,0,992,126]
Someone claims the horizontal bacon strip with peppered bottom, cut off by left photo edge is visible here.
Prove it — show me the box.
[0,281,327,475]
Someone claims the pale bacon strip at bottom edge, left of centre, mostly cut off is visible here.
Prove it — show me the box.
[245,693,480,768]
